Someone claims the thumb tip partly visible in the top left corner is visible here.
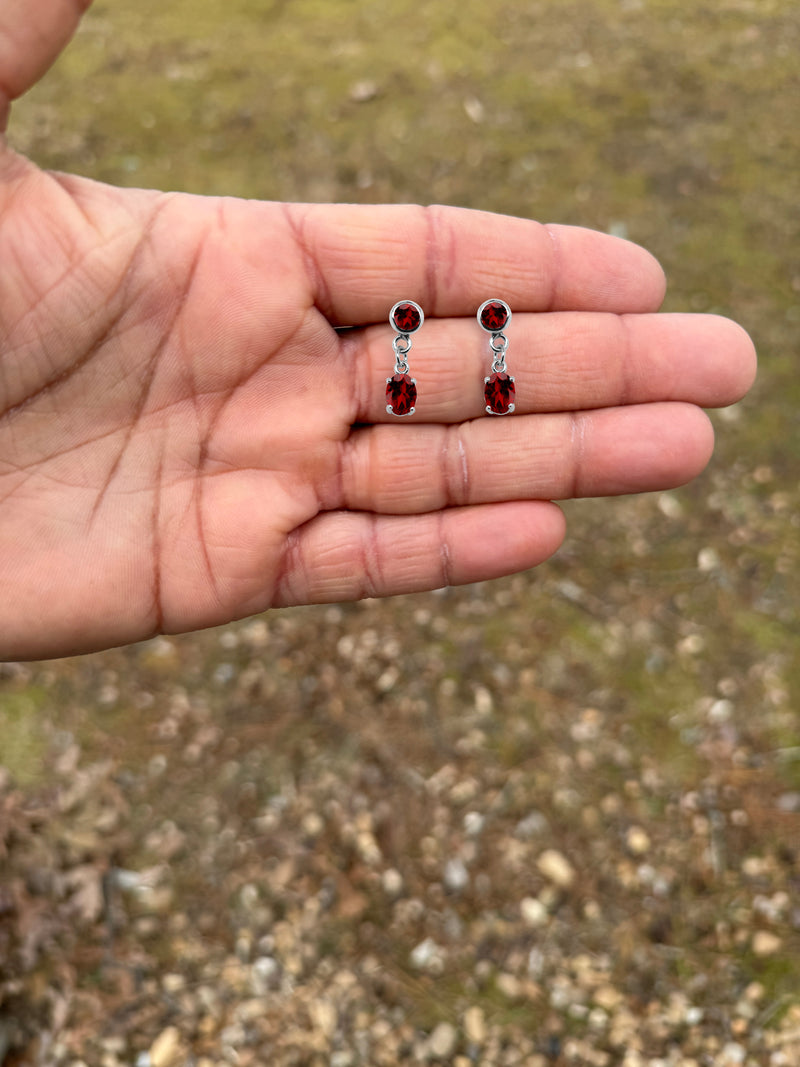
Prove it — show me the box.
[0,0,92,132]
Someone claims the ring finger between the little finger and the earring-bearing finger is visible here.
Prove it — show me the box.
[332,403,714,514]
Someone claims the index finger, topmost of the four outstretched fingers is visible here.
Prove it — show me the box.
[285,204,665,327]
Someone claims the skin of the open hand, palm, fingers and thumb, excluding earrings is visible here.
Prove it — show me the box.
[0,0,755,659]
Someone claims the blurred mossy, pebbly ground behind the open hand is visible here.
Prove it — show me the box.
[0,0,800,1067]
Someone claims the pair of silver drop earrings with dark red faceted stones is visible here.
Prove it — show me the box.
[386,298,516,416]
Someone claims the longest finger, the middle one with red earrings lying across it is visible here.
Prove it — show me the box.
[349,308,754,423]
